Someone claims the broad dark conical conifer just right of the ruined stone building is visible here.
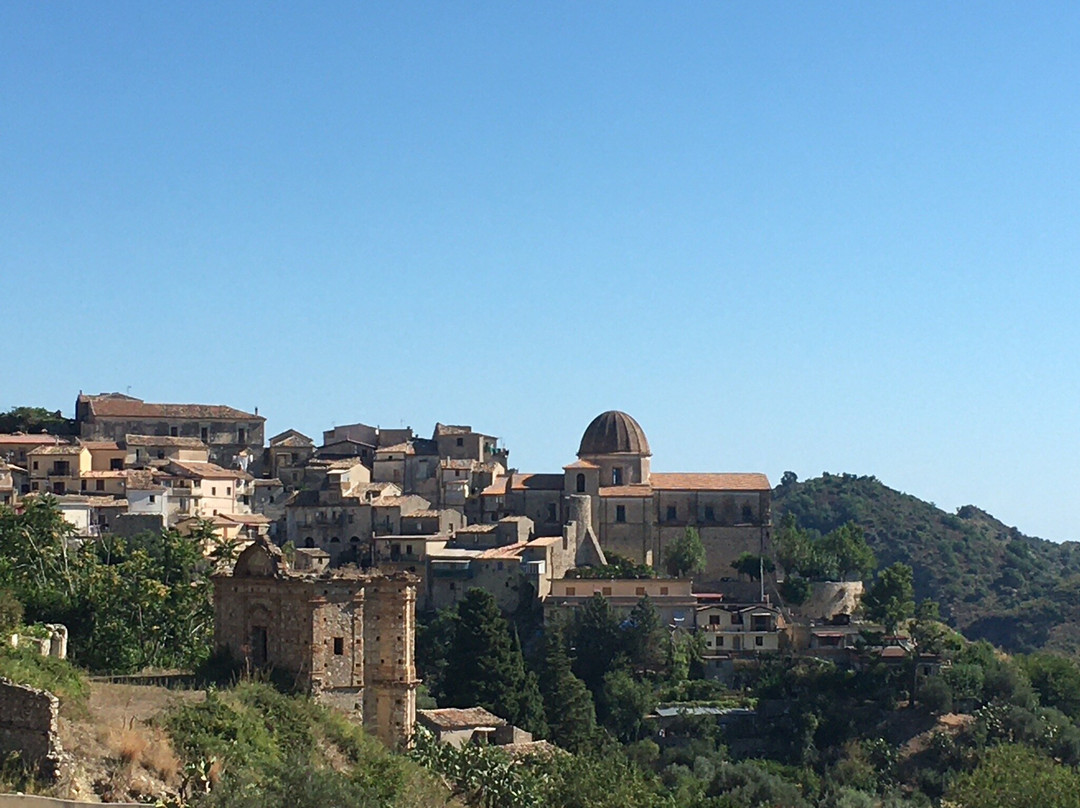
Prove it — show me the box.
[443,589,545,735]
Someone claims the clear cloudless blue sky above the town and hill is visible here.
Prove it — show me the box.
[0,0,1080,540]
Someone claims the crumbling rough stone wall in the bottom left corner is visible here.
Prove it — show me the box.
[0,677,63,781]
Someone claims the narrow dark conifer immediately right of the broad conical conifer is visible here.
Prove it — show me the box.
[540,625,596,752]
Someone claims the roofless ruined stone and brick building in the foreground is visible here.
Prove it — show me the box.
[214,539,419,746]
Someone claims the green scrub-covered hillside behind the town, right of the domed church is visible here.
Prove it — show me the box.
[772,474,1080,654]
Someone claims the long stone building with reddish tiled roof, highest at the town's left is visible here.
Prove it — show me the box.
[75,393,266,466]
